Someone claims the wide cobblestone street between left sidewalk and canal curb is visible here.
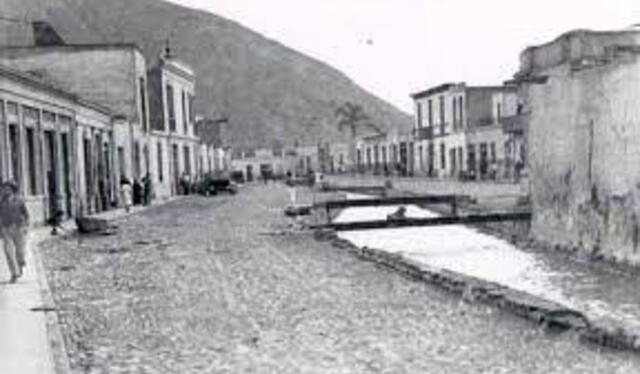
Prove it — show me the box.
[41,184,640,373]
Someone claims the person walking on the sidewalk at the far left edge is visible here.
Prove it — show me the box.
[0,182,29,283]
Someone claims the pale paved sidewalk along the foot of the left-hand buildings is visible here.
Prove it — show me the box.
[0,197,178,374]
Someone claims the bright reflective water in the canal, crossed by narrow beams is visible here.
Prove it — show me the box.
[335,196,640,331]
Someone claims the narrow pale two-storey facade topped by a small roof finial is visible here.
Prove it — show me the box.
[149,50,200,196]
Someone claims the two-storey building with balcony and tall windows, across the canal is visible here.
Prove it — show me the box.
[411,83,517,179]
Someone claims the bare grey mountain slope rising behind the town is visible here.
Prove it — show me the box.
[0,0,411,146]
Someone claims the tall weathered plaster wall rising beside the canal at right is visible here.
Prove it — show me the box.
[525,56,640,264]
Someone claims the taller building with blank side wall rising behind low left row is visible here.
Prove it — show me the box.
[0,44,149,188]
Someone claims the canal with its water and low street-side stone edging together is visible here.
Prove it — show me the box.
[312,190,640,351]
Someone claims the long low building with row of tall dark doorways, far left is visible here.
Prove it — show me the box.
[0,65,112,223]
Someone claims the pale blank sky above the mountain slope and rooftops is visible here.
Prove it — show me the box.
[166,0,640,112]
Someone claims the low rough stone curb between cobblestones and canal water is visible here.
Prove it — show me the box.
[314,230,640,353]
